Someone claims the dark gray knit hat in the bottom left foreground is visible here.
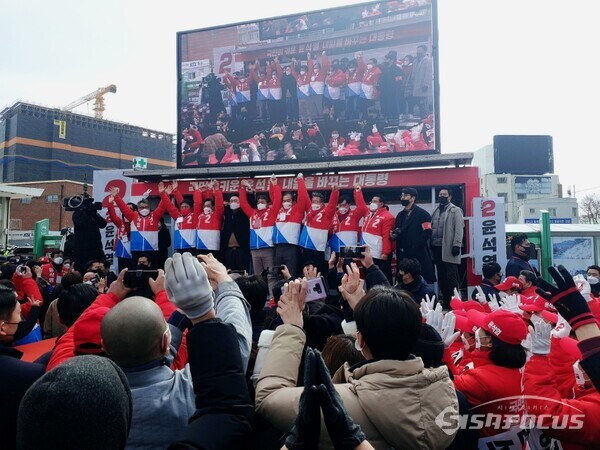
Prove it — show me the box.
[17,355,132,450]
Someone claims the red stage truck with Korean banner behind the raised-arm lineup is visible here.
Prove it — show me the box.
[101,154,486,295]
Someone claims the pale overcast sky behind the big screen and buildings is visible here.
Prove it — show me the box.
[0,0,600,199]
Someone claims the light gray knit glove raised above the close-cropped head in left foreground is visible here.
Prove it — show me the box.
[165,252,214,319]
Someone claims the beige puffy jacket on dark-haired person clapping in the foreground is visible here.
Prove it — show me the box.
[256,325,458,450]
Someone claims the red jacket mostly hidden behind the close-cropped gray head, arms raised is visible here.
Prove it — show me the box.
[46,290,188,372]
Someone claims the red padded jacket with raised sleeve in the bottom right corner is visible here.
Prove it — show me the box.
[523,355,600,450]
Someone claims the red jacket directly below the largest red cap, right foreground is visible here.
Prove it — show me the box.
[454,364,523,440]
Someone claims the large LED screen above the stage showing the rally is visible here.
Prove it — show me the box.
[177,0,439,171]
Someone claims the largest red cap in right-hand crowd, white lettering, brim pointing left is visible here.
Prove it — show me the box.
[467,309,529,345]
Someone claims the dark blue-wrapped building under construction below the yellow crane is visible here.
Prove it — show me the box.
[0,102,175,183]
